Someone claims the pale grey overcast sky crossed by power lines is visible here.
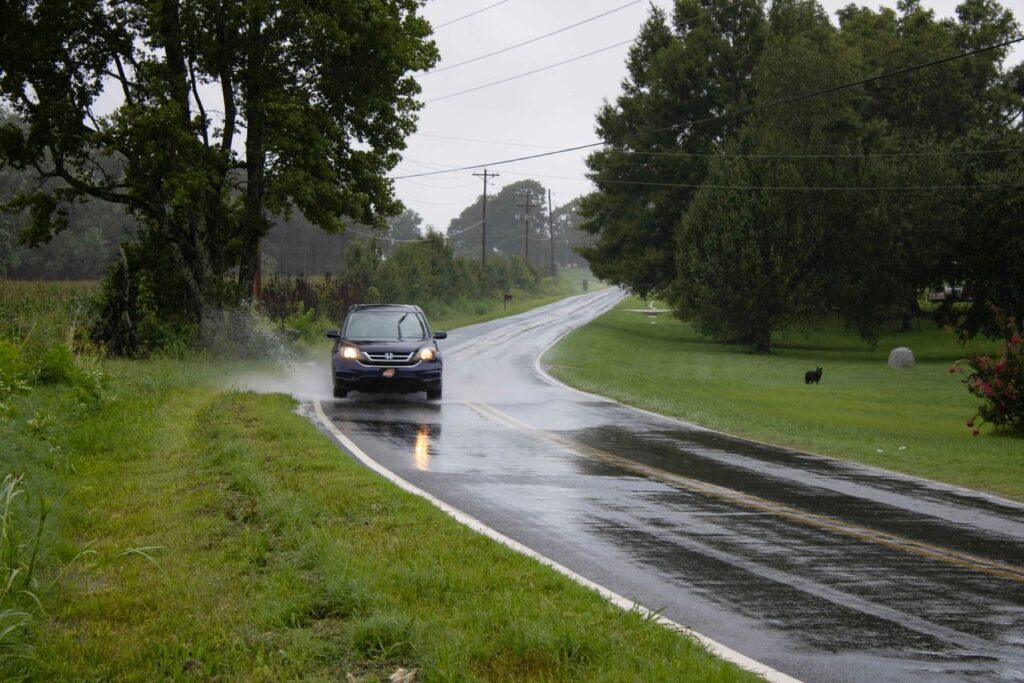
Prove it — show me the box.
[391,0,1024,230]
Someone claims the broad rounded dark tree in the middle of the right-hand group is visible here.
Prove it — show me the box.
[677,0,991,350]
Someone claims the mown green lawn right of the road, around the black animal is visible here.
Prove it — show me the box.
[545,300,1024,500]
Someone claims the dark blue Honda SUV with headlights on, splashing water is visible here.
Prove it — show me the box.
[327,304,447,400]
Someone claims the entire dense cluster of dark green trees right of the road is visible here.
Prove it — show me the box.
[582,0,1024,351]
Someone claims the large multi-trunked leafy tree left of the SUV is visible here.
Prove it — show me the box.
[0,0,437,348]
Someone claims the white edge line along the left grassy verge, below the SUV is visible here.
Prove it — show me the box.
[313,400,800,683]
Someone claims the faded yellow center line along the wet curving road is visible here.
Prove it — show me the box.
[467,403,1024,583]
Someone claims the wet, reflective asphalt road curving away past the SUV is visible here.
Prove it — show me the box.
[323,290,1024,681]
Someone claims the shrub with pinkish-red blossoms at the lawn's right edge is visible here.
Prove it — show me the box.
[949,318,1024,436]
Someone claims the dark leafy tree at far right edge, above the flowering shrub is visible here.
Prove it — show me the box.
[834,0,1024,335]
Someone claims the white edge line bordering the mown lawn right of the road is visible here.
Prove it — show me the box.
[534,294,1024,509]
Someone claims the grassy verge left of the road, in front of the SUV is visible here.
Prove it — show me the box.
[0,360,754,681]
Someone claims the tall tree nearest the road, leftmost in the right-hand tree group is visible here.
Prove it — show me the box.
[580,0,764,295]
